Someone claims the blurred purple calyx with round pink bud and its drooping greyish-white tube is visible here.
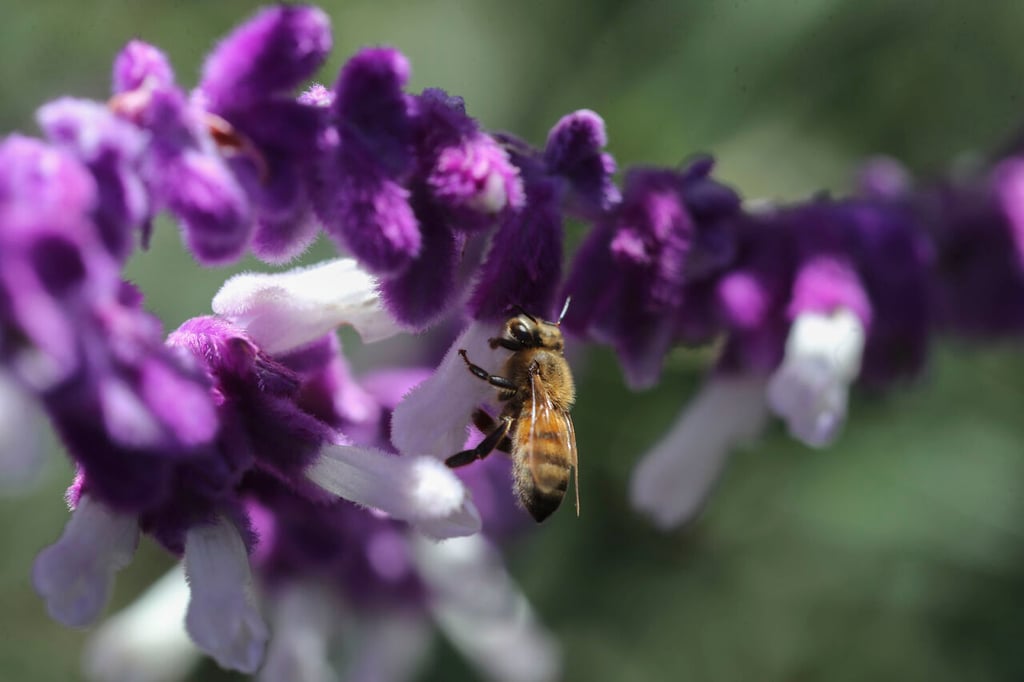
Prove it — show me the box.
[630,204,796,522]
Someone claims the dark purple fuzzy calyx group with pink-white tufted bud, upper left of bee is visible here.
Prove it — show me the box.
[316,48,523,329]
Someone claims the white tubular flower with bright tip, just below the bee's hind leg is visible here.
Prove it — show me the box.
[306,444,480,540]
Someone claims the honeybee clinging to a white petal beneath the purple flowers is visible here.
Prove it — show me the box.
[444,300,580,522]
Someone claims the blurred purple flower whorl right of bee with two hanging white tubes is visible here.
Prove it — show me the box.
[627,191,930,527]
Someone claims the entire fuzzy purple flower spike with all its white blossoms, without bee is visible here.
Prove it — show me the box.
[0,5,1024,680]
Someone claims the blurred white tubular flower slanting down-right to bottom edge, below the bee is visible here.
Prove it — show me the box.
[414,536,561,682]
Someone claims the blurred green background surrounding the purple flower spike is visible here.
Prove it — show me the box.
[0,0,1024,681]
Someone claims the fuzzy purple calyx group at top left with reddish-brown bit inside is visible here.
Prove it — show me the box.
[101,5,331,264]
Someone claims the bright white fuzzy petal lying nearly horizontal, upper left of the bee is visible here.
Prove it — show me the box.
[213,253,402,355]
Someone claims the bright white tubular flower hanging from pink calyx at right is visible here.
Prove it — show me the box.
[768,308,865,447]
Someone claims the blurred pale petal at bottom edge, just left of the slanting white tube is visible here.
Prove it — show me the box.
[341,611,433,682]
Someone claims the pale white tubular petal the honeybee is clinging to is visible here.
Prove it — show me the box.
[391,322,509,460]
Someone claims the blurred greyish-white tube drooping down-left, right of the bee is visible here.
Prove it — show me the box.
[630,377,767,529]
